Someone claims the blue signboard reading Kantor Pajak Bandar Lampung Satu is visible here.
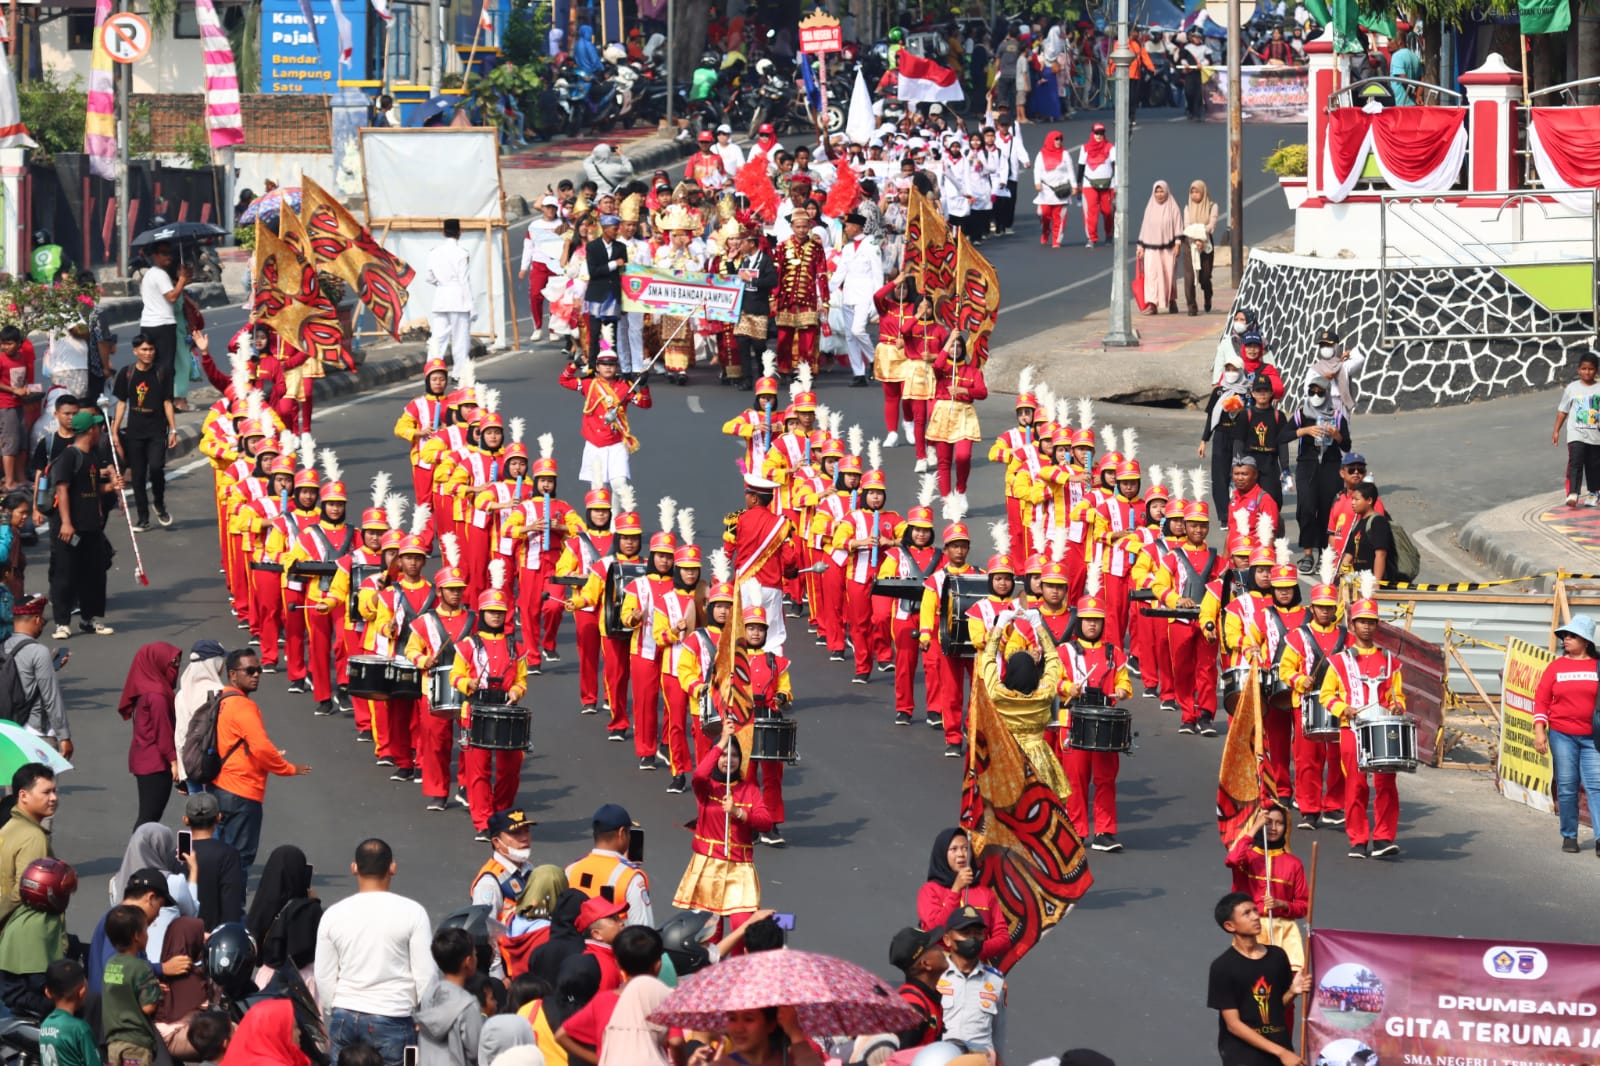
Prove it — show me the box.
[261,0,366,93]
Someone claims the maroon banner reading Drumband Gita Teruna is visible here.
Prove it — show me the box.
[1304,928,1600,1066]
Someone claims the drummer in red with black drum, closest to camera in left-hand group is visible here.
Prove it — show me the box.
[450,562,528,842]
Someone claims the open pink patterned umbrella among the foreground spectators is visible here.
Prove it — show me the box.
[650,948,918,1036]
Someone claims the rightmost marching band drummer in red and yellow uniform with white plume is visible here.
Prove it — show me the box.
[1322,571,1405,858]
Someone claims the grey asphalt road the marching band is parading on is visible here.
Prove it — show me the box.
[56,118,1600,1063]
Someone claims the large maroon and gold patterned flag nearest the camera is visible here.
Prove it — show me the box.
[962,640,1094,972]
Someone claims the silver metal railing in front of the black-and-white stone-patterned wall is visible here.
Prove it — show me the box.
[1378,189,1600,347]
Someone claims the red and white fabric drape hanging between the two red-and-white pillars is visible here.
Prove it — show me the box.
[1323,104,1467,203]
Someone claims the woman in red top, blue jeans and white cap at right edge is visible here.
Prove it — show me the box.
[1533,615,1600,856]
